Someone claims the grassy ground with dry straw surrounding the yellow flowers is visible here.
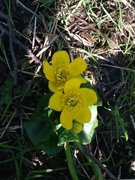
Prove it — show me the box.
[0,0,135,180]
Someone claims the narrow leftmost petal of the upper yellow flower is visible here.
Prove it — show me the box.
[43,61,55,82]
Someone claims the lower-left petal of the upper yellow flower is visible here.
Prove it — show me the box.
[48,81,64,92]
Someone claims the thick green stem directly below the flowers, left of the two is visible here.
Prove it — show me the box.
[64,142,79,180]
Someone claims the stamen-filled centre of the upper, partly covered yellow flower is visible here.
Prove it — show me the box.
[55,66,70,84]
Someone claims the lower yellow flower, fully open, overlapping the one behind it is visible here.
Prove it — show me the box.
[49,78,97,132]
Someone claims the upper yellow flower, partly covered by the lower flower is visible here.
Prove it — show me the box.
[43,50,87,92]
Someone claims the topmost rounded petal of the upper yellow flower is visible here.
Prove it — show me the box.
[52,50,70,66]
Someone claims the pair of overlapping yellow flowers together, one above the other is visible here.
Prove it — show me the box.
[43,50,97,133]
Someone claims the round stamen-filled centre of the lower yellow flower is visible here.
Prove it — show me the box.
[62,92,82,112]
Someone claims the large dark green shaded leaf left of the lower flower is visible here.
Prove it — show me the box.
[24,94,61,155]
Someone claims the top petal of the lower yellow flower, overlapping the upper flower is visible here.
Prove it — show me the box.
[64,77,82,93]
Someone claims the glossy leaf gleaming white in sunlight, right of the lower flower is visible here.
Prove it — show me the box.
[78,105,98,145]
